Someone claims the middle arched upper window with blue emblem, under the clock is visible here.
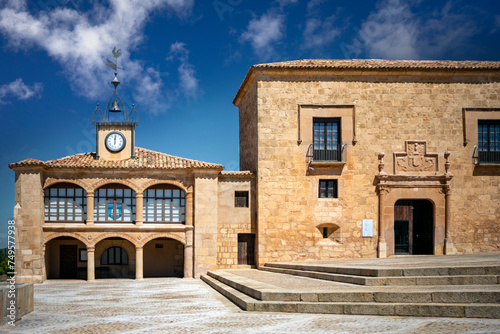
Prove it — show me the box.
[94,184,135,223]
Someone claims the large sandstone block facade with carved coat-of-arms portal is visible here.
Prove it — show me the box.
[234,60,500,265]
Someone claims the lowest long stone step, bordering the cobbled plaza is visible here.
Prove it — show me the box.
[201,275,500,319]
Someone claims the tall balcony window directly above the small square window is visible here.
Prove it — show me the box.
[313,118,342,161]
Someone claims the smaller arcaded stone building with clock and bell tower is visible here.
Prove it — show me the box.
[10,72,255,283]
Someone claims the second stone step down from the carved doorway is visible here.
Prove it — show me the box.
[260,265,500,286]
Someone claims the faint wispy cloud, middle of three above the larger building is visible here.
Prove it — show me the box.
[302,0,341,49]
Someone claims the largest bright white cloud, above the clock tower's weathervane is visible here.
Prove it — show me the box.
[0,0,194,113]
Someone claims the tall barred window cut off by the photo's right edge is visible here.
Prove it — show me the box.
[477,121,500,163]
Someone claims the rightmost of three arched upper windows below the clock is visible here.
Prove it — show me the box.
[143,185,186,224]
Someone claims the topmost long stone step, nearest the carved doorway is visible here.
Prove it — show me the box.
[261,263,500,277]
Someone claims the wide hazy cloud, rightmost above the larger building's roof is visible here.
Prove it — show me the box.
[359,0,476,59]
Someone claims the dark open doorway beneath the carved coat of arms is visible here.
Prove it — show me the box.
[394,200,434,255]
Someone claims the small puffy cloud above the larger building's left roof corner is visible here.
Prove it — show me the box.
[239,10,285,61]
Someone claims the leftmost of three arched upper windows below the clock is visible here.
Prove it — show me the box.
[44,183,87,222]
